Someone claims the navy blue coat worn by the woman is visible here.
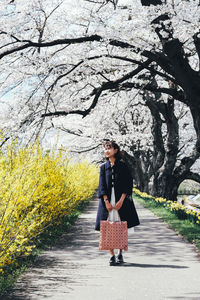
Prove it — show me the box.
[95,160,140,231]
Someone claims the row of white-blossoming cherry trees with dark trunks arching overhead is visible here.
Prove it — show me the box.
[0,0,200,200]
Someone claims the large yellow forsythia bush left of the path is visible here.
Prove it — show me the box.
[0,142,98,272]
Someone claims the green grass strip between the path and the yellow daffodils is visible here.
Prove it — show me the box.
[134,194,200,251]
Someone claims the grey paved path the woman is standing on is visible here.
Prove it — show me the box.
[1,196,200,300]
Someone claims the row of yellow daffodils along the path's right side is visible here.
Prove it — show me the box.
[133,188,200,225]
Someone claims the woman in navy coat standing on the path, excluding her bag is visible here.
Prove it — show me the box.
[95,141,140,265]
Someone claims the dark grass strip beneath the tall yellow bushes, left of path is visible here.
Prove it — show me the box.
[0,199,90,295]
